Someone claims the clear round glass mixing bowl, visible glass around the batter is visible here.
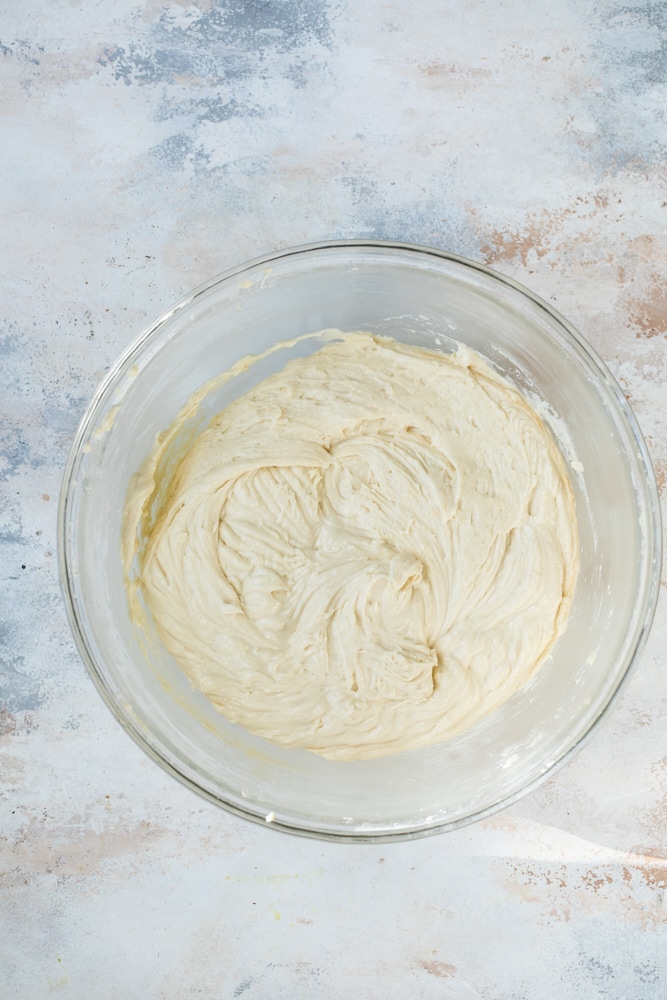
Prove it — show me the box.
[59,241,661,841]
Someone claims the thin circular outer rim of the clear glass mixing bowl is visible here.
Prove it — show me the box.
[57,239,663,844]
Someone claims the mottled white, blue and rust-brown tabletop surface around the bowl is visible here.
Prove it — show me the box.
[0,0,667,1000]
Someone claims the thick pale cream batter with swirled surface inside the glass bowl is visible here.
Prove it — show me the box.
[126,333,578,759]
